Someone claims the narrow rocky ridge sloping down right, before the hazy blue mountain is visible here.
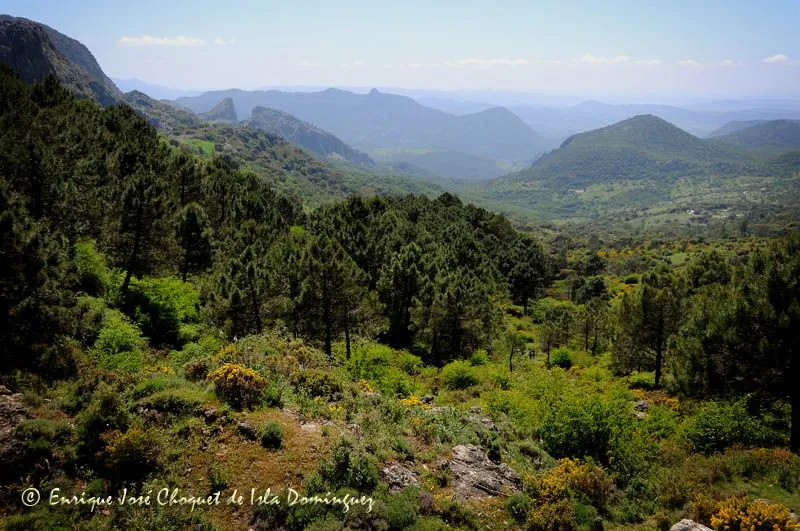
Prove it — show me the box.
[245,107,375,166]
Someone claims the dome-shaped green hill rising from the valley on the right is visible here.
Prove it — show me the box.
[504,115,744,188]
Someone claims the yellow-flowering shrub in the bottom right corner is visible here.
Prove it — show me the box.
[711,497,796,531]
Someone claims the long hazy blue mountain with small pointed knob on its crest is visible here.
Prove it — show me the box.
[177,89,545,161]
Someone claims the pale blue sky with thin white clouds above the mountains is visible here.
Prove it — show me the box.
[0,0,800,99]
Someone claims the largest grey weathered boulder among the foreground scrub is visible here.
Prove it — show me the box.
[442,444,522,500]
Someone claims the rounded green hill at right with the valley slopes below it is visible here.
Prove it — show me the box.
[460,115,800,224]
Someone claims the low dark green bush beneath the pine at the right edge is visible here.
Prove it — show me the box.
[683,399,775,454]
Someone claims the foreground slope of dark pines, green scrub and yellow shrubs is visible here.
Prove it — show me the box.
[0,65,800,531]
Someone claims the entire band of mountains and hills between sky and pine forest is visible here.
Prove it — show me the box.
[0,12,800,221]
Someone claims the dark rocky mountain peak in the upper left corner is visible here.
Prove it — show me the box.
[0,15,122,105]
